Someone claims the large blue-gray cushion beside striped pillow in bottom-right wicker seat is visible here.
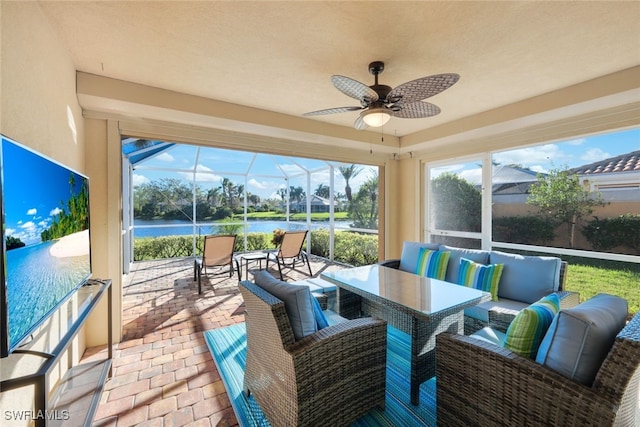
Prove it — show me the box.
[536,294,627,386]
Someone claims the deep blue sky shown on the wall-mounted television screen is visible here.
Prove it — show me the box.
[2,137,87,245]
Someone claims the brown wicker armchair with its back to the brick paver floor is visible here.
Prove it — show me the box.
[239,281,387,426]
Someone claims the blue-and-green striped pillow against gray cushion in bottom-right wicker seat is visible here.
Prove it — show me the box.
[502,294,560,359]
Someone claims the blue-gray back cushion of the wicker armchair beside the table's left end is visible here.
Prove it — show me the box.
[253,270,318,340]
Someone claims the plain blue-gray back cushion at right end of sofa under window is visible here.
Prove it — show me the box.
[489,251,562,304]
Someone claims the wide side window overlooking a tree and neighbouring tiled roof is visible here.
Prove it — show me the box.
[425,129,640,262]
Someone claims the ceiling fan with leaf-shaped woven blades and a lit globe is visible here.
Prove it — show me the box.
[303,61,460,130]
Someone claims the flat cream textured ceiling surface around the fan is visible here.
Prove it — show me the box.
[40,1,640,140]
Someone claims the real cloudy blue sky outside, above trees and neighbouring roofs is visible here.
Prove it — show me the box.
[134,129,640,198]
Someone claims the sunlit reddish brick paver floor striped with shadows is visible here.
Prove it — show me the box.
[84,256,344,427]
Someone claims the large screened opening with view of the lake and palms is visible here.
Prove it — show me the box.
[122,138,379,269]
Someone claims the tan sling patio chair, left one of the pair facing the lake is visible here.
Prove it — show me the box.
[193,234,242,294]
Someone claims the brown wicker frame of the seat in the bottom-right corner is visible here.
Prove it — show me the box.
[436,314,640,427]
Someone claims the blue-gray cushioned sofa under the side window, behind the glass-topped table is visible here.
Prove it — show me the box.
[380,241,580,335]
